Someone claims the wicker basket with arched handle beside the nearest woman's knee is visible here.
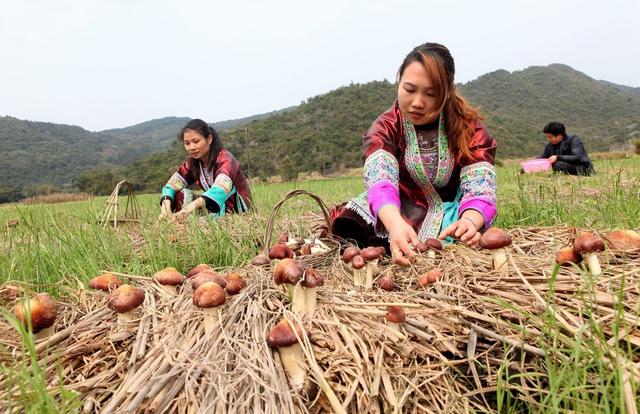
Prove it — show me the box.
[263,190,340,268]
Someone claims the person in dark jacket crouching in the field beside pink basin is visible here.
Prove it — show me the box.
[540,122,595,175]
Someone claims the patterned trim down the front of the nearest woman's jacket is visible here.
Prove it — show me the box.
[401,114,454,240]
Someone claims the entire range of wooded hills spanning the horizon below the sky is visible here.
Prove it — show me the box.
[0,64,640,200]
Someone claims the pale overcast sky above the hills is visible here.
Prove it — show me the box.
[0,0,640,131]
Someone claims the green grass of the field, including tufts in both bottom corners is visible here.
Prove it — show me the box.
[0,157,640,413]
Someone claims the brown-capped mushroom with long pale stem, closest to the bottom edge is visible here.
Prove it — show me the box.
[267,319,307,391]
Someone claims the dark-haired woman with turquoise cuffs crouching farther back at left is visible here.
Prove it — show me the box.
[160,119,251,216]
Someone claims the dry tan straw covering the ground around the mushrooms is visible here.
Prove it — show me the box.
[0,227,640,413]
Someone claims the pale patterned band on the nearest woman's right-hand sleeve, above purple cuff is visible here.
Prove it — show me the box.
[460,161,497,206]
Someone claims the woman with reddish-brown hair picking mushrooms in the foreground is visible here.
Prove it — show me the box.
[332,43,497,261]
